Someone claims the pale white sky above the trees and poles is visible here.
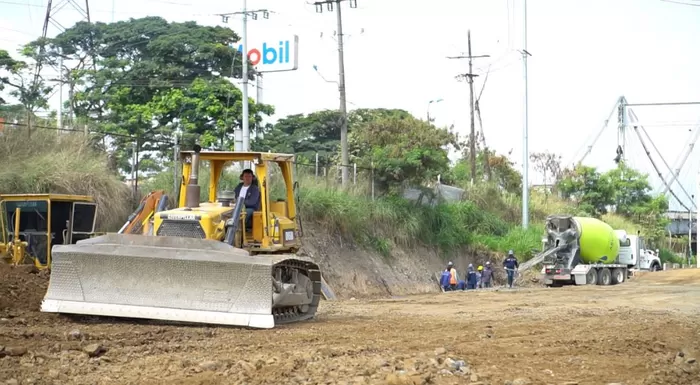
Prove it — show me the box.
[0,0,700,210]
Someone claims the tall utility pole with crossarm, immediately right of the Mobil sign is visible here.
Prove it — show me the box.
[314,0,357,186]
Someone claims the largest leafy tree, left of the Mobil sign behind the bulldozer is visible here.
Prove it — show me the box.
[26,17,262,169]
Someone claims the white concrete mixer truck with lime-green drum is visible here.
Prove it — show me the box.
[542,215,661,287]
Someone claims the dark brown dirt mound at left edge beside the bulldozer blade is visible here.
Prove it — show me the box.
[0,262,49,317]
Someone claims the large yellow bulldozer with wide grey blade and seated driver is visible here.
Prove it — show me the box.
[41,146,321,328]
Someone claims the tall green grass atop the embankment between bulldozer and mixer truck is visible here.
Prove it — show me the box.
[284,176,542,259]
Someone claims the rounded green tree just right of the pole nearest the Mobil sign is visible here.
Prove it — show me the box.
[349,115,457,193]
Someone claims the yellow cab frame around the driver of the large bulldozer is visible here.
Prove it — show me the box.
[178,151,301,254]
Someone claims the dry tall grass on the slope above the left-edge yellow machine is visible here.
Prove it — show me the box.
[0,129,134,231]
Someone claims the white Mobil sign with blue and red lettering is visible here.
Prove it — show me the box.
[234,35,299,72]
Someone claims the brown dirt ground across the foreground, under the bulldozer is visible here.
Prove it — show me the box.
[0,267,700,385]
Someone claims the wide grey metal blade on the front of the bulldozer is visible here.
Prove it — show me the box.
[41,234,275,329]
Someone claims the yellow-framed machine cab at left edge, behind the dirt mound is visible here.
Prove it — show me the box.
[0,194,97,268]
